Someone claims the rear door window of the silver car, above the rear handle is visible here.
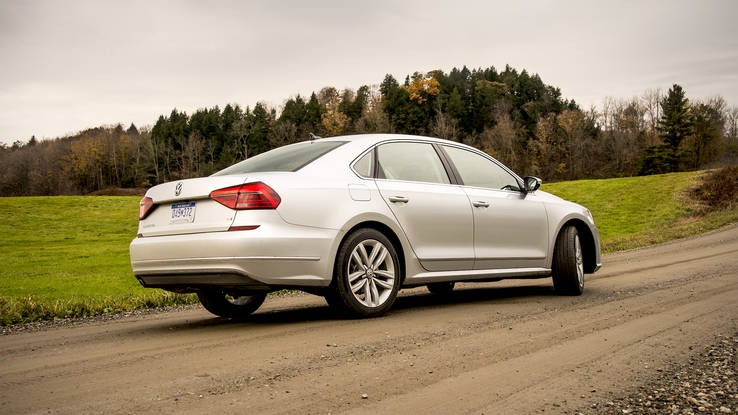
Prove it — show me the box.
[377,143,450,184]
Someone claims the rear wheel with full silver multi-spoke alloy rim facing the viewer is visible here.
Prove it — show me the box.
[326,228,402,317]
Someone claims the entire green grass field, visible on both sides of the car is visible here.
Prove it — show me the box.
[0,173,738,325]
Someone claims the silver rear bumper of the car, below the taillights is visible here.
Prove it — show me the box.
[130,226,338,291]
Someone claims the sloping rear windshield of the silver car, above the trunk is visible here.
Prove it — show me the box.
[208,141,346,176]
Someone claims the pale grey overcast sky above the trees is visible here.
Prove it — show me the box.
[0,0,738,143]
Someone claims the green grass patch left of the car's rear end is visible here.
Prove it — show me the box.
[0,196,193,325]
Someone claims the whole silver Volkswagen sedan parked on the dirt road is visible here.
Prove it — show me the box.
[130,134,601,317]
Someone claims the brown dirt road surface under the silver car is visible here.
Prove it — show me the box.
[0,227,738,414]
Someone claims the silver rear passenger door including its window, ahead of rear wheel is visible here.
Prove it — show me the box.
[376,142,474,271]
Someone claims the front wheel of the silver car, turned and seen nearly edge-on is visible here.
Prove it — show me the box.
[551,226,584,295]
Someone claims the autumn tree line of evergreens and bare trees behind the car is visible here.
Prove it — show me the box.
[0,66,738,196]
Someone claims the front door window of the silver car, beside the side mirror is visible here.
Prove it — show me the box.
[443,146,520,191]
